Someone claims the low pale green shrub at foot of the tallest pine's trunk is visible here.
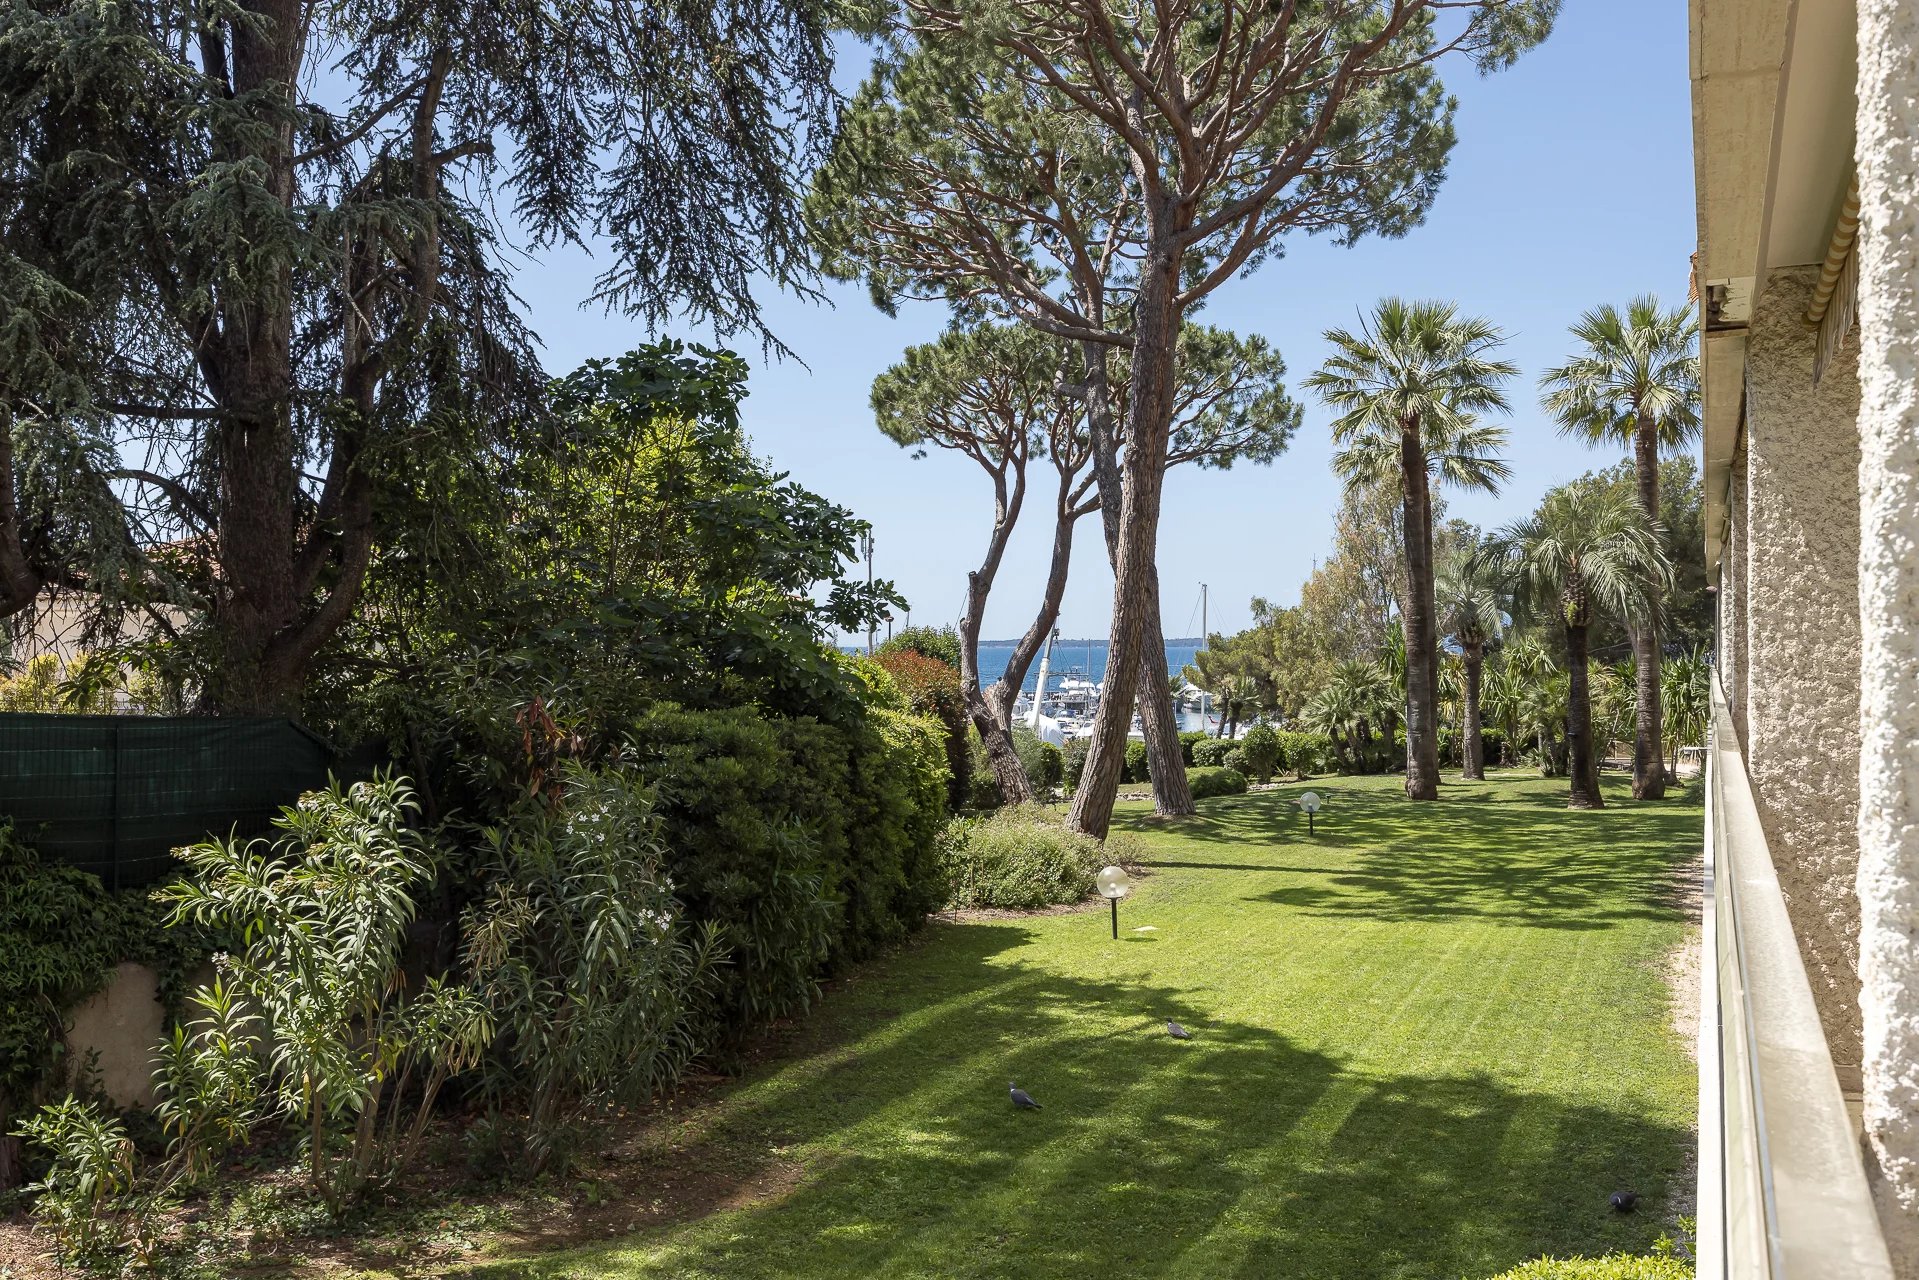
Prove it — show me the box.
[940,804,1138,912]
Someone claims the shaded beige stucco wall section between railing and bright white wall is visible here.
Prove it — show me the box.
[1742,267,1861,1092]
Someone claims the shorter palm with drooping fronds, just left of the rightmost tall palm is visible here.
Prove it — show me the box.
[1489,482,1671,808]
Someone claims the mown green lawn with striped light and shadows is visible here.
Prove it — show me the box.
[484,775,1700,1280]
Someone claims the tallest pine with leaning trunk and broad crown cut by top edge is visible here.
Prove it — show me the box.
[810,0,1558,835]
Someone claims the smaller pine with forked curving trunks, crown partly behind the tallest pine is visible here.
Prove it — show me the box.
[873,324,1299,808]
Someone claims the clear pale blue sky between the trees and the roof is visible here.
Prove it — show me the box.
[516,0,1694,639]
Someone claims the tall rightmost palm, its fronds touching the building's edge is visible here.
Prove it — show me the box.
[1541,294,1700,800]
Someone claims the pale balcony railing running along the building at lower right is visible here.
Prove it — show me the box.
[1696,679,1892,1280]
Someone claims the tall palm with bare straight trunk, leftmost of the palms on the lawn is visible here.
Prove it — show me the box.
[1307,297,1518,800]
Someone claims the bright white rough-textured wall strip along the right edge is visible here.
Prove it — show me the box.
[1858,0,1919,1276]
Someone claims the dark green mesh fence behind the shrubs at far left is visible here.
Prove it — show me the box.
[0,714,338,889]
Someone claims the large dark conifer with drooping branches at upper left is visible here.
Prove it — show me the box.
[0,0,837,710]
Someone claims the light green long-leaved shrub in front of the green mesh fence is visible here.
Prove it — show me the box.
[155,777,493,1217]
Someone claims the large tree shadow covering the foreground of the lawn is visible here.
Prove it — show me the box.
[474,925,1689,1280]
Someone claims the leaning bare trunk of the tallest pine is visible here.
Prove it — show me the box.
[1067,247,1192,839]
